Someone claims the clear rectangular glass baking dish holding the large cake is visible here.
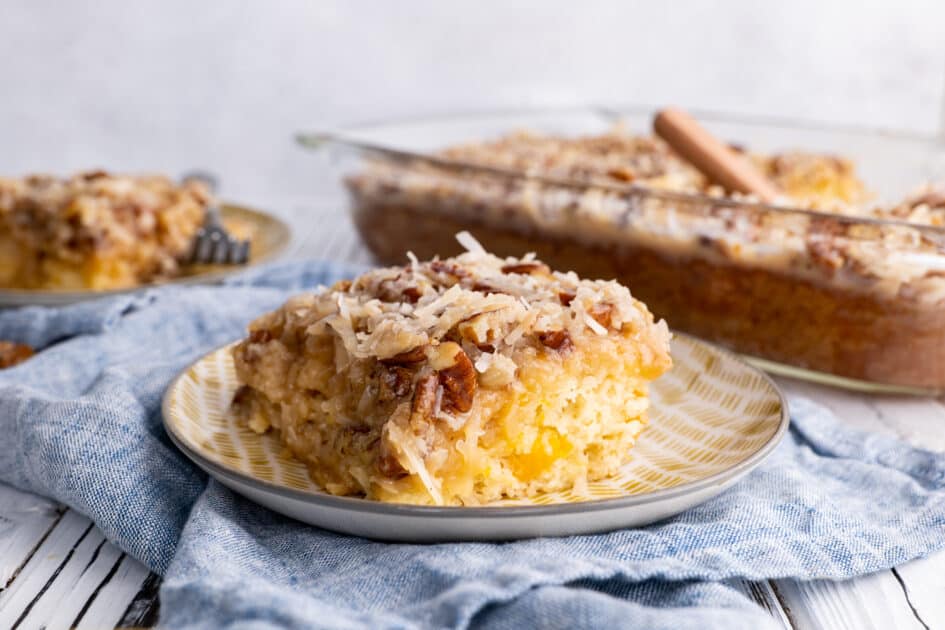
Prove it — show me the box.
[300,109,945,393]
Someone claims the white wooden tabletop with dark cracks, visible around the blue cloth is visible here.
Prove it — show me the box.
[0,204,945,630]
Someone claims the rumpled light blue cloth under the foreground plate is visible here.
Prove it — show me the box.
[0,263,945,630]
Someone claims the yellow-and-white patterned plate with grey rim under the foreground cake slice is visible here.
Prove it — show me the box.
[164,334,789,542]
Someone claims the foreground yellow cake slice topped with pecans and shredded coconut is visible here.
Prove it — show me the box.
[233,234,671,505]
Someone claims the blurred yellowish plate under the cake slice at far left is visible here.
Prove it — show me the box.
[0,204,291,307]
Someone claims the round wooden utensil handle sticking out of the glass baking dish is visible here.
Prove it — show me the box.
[653,108,780,203]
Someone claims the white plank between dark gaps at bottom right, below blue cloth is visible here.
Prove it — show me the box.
[774,571,925,630]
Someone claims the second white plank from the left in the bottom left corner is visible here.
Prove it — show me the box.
[0,510,93,628]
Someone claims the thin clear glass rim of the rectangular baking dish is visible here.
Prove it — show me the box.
[295,106,945,238]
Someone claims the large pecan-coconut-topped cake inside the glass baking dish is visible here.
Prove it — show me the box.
[346,132,945,390]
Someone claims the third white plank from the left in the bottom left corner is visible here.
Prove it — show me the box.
[20,527,112,630]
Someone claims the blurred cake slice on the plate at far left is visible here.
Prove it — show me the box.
[0,172,210,290]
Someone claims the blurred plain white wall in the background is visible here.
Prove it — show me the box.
[0,0,945,200]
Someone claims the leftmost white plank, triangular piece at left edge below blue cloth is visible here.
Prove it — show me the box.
[0,484,60,592]
